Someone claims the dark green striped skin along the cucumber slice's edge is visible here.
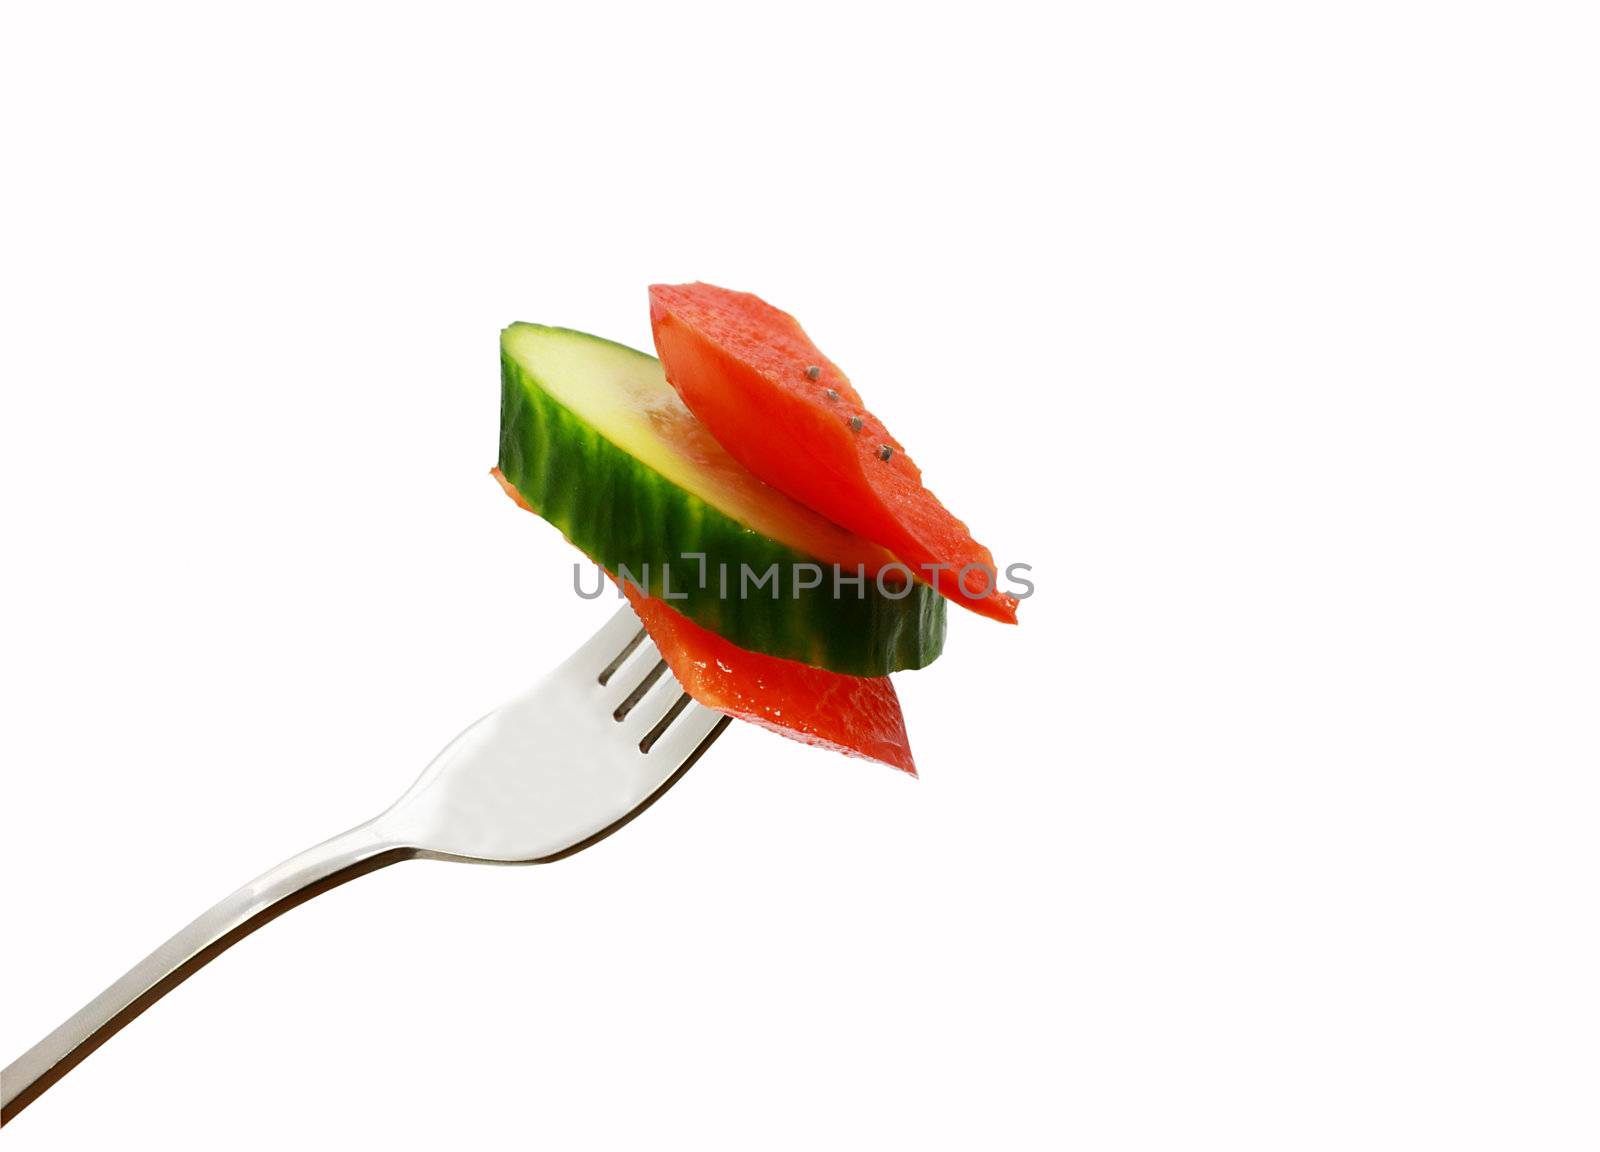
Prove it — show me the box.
[499,333,946,677]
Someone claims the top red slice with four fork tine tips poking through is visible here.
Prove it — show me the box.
[650,283,1018,624]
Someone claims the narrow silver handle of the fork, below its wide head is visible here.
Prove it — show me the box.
[0,822,416,1123]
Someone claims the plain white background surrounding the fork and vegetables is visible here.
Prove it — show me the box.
[0,3,1600,1152]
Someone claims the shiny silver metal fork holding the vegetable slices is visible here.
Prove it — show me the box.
[0,606,728,1123]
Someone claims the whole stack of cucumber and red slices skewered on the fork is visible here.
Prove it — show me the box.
[496,285,1016,773]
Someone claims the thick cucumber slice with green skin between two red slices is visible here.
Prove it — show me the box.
[499,323,944,677]
